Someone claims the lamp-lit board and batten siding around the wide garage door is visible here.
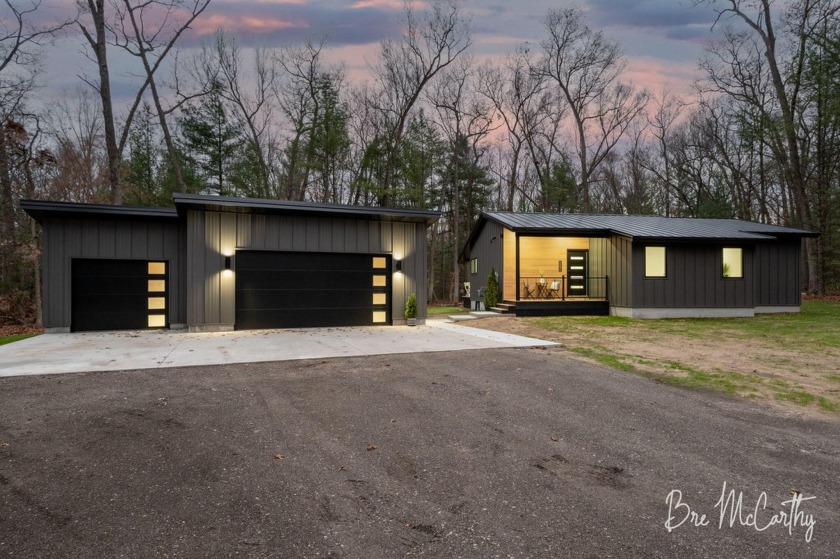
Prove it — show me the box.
[187,210,426,327]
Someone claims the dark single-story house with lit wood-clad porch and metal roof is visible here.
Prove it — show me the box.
[464,212,818,318]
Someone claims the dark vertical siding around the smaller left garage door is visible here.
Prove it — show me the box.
[42,213,187,328]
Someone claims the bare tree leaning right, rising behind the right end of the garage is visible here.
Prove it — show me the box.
[372,0,470,206]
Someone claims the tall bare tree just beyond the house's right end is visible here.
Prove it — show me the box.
[697,0,840,293]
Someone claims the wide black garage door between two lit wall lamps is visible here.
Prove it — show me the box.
[236,251,391,329]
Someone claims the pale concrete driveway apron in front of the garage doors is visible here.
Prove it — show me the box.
[0,320,557,377]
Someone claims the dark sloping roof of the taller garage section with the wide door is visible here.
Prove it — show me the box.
[173,194,440,223]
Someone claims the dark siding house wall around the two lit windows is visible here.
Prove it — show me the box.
[632,243,755,308]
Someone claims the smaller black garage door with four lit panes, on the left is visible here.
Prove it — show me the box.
[71,259,168,332]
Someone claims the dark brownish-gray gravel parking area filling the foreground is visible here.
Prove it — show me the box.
[0,348,840,558]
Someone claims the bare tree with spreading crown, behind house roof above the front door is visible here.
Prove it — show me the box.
[542,8,648,212]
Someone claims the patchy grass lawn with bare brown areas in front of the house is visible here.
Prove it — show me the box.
[476,301,840,415]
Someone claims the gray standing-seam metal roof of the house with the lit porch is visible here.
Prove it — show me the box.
[477,212,819,240]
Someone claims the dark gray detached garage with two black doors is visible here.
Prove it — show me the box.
[21,194,440,332]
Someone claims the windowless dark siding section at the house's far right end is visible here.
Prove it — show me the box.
[754,239,802,306]
